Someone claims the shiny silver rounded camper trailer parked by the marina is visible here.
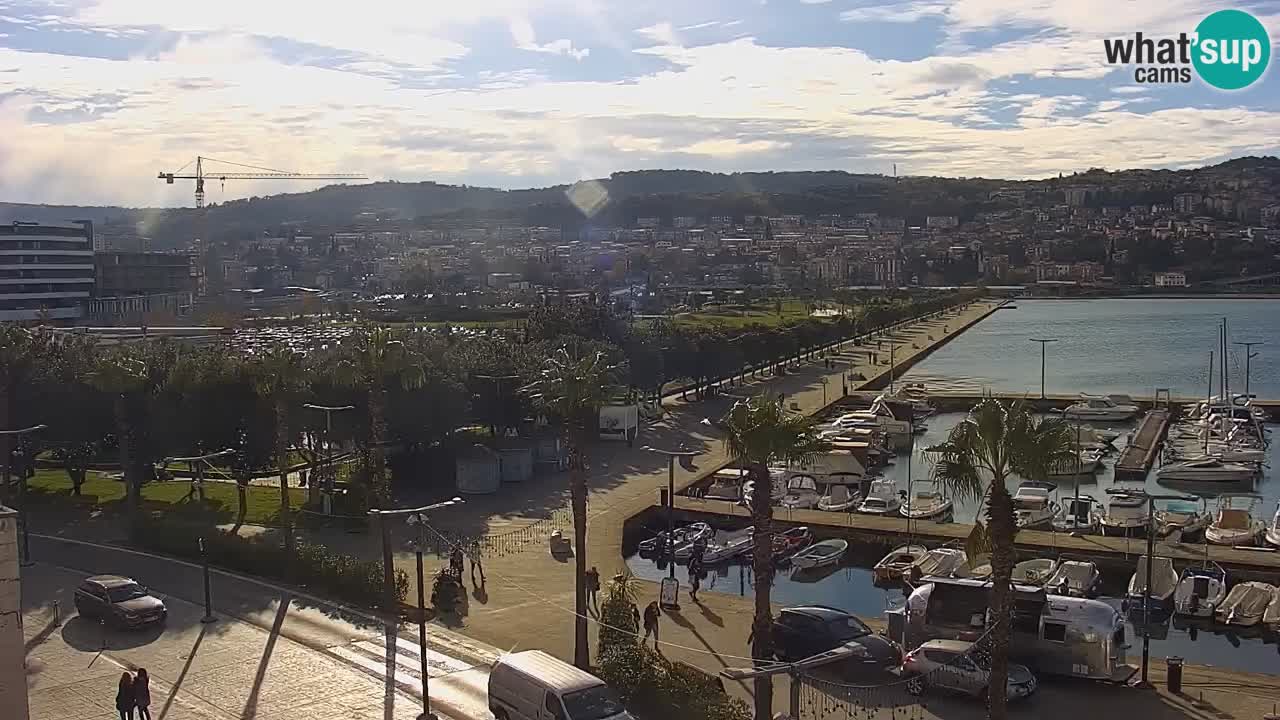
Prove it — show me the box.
[891,578,1134,683]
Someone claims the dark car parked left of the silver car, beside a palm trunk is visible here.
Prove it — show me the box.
[773,605,902,671]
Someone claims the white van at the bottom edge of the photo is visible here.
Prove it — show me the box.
[489,650,632,720]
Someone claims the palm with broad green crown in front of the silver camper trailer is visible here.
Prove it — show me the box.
[925,398,1073,720]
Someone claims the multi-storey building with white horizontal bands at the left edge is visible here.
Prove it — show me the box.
[0,222,93,322]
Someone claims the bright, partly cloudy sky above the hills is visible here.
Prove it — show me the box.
[0,0,1280,206]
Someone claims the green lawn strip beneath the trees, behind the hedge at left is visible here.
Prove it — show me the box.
[27,469,307,525]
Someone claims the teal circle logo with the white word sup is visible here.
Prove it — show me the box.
[1192,10,1271,90]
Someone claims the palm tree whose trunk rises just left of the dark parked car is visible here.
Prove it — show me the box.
[724,395,831,720]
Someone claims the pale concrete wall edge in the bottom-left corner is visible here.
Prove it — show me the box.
[0,505,29,720]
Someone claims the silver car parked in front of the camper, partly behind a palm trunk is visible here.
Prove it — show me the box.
[902,641,1037,702]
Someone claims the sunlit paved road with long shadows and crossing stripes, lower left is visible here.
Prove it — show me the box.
[23,537,499,720]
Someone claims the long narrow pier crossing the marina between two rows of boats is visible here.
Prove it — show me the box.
[652,496,1280,583]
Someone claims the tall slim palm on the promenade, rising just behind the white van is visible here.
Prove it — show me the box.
[525,346,617,670]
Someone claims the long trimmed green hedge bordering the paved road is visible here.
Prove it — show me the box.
[133,512,408,610]
